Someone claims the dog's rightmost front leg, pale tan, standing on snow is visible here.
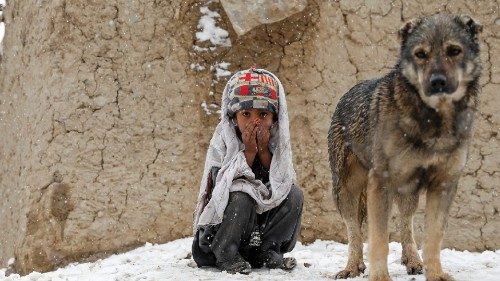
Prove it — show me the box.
[423,179,457,281]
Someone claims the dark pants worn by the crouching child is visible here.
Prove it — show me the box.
[192,185,304,267]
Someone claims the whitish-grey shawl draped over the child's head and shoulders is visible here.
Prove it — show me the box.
[193,69,296,233]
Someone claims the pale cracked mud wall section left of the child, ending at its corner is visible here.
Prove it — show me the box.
[0,1,205,273]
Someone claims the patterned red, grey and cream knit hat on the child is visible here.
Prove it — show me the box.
[226,67,278,117]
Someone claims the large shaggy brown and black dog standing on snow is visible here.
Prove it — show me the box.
[328,14,482,281]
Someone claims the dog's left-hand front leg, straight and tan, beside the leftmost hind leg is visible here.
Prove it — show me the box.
[367,169,392,281]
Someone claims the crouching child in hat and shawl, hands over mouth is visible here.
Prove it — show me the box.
[193,68,303,274]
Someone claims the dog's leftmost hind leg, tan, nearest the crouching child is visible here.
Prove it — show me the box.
[335,152,368,279]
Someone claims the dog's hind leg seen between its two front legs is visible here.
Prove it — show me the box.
[395,191,423,275]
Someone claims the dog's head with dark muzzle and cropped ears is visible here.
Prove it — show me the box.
[399,14,482,109]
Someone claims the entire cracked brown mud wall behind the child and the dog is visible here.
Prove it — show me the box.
[0,0,500,273]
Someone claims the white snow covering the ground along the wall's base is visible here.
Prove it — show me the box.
[0,238,500,281]
